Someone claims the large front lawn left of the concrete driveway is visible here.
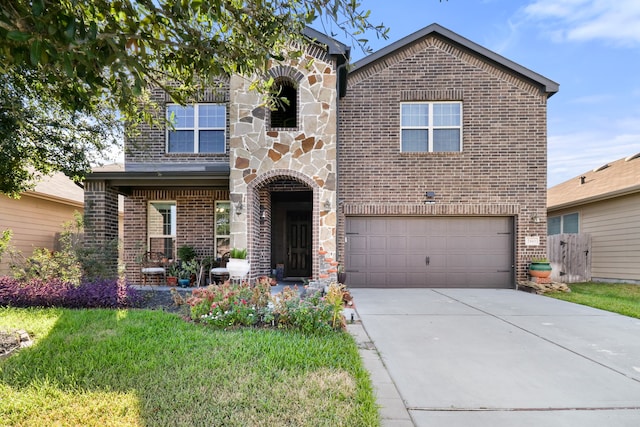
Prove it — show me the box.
[0,308,379,426]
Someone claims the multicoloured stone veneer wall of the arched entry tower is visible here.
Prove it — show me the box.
[229,50,337,275]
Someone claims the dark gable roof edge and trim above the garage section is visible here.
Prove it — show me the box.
[351,24,559,97]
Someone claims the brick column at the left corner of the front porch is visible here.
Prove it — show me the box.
[84,181,118,278]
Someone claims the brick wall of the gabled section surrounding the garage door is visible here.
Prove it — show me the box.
[338,36,547,279]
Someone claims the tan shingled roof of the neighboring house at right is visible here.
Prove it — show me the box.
[547,153,640,209]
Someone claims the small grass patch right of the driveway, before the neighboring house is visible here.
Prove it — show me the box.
[547,282,640,319]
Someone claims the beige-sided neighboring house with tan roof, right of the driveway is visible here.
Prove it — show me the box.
[547,153,640,283]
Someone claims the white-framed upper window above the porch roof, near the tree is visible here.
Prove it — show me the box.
[167,104,227,153]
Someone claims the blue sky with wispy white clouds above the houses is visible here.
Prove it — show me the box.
[330,0,640,187]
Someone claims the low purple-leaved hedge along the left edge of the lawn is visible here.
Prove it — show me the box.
[0,277,140,308]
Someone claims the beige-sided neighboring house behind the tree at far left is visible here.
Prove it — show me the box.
[0,173,84,274]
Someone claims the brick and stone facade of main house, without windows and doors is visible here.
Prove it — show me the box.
[85,25,557,288]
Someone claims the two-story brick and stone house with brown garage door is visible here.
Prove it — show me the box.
[85,24,558,287]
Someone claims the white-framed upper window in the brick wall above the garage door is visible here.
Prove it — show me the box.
[400,102,462,152]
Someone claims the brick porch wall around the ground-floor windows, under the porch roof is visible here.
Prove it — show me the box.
[124,189,229,283]
